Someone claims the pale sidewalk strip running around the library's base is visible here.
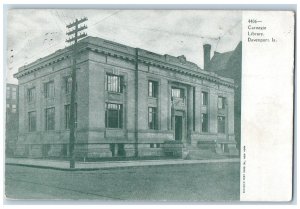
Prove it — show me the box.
[5,158,240,171]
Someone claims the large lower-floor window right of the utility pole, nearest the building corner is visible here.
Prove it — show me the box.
[105,103,123,128]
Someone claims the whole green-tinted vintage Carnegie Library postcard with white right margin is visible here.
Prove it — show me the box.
[4,8,295,202]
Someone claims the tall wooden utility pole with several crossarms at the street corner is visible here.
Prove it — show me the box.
[66,17,87,168]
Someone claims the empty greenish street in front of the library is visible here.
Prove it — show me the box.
[5,163,240,201]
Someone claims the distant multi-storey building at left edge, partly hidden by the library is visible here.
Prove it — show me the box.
[5,83,19,157]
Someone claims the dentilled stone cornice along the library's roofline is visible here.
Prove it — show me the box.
[14,37,235,88]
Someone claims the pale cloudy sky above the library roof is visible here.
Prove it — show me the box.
[6,9,242,83]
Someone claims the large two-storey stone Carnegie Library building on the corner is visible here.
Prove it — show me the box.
[15,37,237,158]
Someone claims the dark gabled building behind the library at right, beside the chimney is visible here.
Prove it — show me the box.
[208,42,242,148]
